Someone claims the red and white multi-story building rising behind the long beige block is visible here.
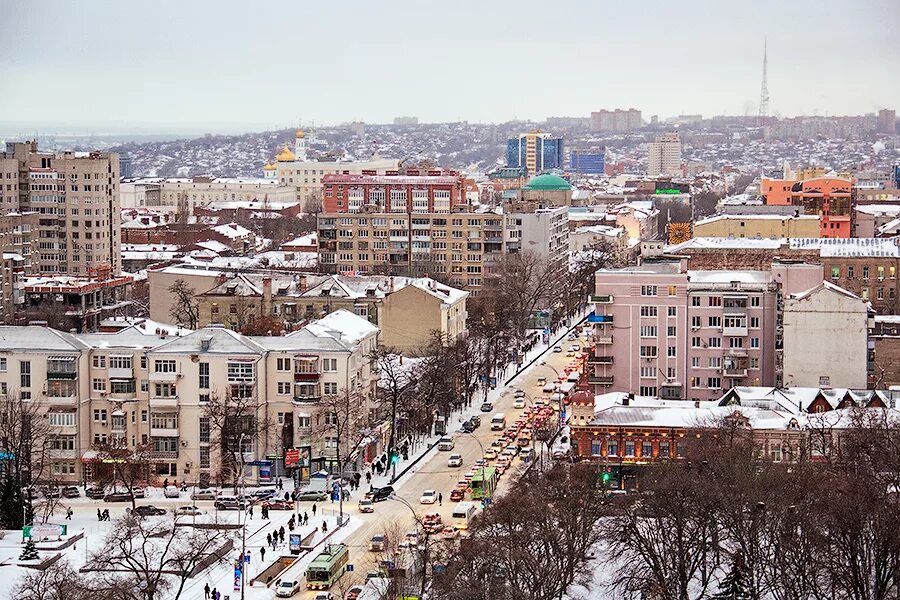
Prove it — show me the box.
[322,170,469,214]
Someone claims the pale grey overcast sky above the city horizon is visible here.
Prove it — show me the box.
[0,0,900,130]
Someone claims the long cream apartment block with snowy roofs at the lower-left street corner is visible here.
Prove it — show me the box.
[0,311,383,483]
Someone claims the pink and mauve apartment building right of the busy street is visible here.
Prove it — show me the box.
[588,260,821,400]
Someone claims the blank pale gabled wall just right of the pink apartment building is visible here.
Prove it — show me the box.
[776,281,874,389]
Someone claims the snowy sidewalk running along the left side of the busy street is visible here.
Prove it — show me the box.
[360,306,592,492]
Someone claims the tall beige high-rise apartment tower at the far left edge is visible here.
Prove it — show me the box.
[0,141,121,276]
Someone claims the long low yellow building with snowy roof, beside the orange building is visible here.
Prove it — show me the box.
[693,215,821,239]
